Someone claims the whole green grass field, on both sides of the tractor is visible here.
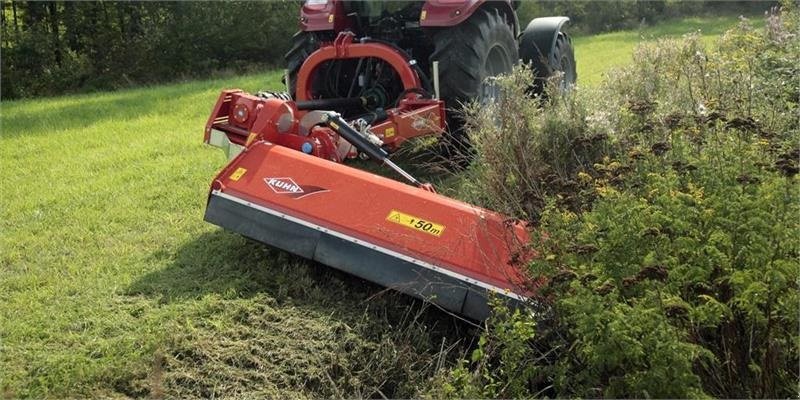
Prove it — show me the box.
[0,14,764,397]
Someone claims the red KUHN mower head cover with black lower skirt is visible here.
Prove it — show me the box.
[205,142,531,320]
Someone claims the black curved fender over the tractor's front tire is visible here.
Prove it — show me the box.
[519,17,569,70]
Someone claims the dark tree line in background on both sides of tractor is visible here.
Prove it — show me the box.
[0,0,764,99]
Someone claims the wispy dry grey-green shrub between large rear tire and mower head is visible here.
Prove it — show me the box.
[461,69,606,220]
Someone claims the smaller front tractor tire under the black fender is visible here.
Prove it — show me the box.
[519,32,578,95]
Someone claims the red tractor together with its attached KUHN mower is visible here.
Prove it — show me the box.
[204,0,576,320]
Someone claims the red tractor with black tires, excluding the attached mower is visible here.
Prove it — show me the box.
[286,0,577,134]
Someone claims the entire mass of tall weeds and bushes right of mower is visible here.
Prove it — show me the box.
[435,3,800,398]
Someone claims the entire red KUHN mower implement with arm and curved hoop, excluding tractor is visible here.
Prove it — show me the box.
[204,34,536,320]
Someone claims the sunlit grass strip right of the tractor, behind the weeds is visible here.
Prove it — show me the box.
[573,16,764,86]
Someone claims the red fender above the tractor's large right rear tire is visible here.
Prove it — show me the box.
[419,0,519,35]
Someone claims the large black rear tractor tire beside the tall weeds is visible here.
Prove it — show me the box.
[430,8,519,158]
